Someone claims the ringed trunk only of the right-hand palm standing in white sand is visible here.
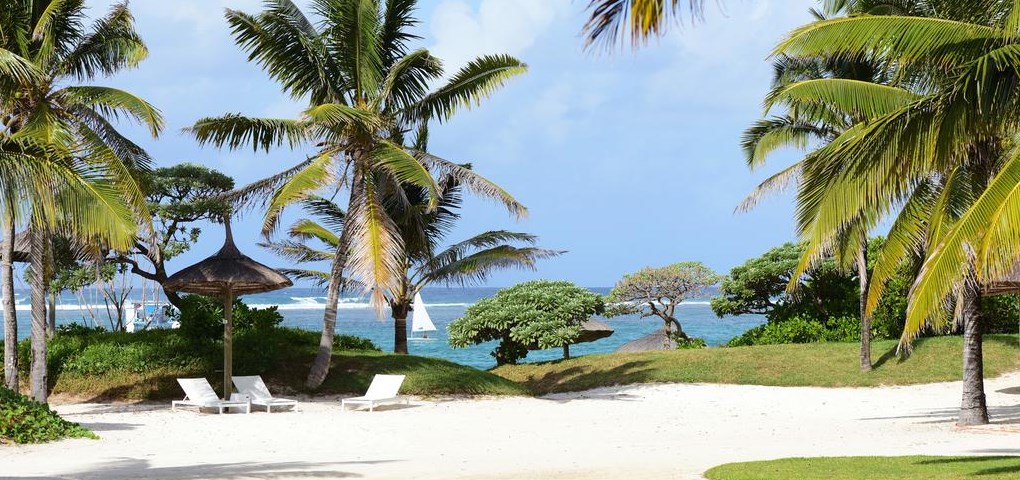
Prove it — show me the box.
[957,284,988,425]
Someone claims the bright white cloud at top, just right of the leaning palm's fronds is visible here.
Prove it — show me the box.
[429,0,570,71]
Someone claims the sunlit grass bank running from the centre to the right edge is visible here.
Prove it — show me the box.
[492,335,1020,394]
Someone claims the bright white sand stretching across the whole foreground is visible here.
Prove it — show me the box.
[0,374,1020,479]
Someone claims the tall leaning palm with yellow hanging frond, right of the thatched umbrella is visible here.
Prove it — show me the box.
[190,0,526,388]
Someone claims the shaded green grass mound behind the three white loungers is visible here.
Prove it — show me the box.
[23,328,529,402]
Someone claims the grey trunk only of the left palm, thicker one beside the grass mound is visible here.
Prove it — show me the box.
[31,228,48,403]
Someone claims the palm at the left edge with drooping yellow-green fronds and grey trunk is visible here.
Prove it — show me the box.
[0,0,163,402]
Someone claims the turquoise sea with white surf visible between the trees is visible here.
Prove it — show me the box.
[0,287,765,369]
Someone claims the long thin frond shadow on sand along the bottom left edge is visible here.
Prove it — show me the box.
[16,459,393,480]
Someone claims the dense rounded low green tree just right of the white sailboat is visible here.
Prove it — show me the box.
[448,280,605,365]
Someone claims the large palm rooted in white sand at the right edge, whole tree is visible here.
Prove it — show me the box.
[776,1,1020,424]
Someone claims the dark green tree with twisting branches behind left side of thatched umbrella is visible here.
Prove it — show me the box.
[112,163,234,308]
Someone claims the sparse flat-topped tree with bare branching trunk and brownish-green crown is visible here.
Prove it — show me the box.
[608,262,722,342]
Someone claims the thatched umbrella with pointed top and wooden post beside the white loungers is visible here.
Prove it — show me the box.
[163,219,294,399]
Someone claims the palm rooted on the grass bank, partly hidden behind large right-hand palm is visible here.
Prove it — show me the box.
[738,1,923,371]
